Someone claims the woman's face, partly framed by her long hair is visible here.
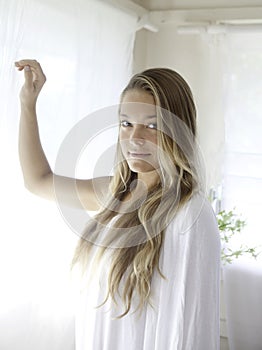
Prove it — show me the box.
[119,89,159,173]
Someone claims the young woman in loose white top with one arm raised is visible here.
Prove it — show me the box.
[16,60,220,350]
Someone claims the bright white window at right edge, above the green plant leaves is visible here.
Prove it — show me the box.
[223,33,262,245]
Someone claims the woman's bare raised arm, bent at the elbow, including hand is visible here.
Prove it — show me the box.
[15,60,110,210]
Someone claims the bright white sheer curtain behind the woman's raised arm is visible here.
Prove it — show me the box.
[0,0,137,350]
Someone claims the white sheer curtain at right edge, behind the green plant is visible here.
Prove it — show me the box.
[223,33,262,350]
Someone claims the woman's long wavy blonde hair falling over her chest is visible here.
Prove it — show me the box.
[73,68,198,317]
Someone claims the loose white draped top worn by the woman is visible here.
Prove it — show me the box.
[75,194,220,350]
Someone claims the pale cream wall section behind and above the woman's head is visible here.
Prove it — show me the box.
[134,23,224,188]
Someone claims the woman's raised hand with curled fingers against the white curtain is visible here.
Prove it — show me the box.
[15,60,46,108]
